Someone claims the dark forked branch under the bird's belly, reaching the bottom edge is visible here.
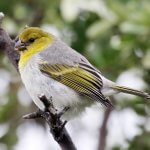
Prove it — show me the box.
[23,95,76,150]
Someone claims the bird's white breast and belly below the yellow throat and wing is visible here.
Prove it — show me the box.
[21,63,93,120]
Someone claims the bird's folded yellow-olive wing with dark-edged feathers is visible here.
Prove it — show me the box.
[39,61,111,106]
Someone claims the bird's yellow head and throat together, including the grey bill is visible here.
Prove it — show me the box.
[15,27,55,68]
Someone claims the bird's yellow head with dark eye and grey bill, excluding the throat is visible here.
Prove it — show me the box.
[15,27,54,52]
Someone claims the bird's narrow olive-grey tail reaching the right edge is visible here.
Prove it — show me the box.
[111,85,150,99]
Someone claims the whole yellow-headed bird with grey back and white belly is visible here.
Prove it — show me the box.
[15,27,150,120]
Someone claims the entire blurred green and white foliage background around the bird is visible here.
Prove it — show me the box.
[0,0,150,150]
